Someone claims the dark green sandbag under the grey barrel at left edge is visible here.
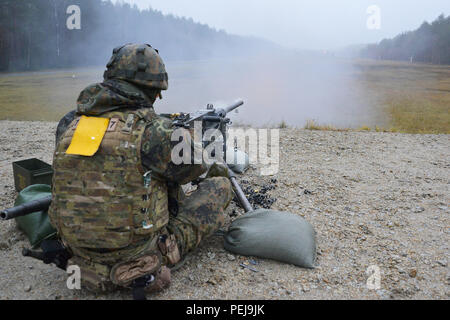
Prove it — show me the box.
[15,184,56,248]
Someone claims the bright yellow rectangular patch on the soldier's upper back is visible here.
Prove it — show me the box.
[66,116,109,157]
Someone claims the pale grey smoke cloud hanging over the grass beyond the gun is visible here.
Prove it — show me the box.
[155,50,373,127]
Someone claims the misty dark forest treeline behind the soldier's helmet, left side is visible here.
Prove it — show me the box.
[0,0,271,71]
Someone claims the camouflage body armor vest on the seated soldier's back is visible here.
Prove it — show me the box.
[49,108,169,256]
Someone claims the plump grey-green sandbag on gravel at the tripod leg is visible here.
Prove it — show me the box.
[224,209,316,268]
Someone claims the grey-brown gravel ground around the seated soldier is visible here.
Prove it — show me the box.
[0,121,450,299]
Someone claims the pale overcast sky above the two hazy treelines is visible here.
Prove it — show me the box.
[114,0,450,49]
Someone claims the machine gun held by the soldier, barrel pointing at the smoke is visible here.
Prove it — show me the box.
[161,100,244,161]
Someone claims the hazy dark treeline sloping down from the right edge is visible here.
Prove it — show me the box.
[360,14,450,64]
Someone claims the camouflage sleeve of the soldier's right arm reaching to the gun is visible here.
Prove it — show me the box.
[141,117,207,184]
